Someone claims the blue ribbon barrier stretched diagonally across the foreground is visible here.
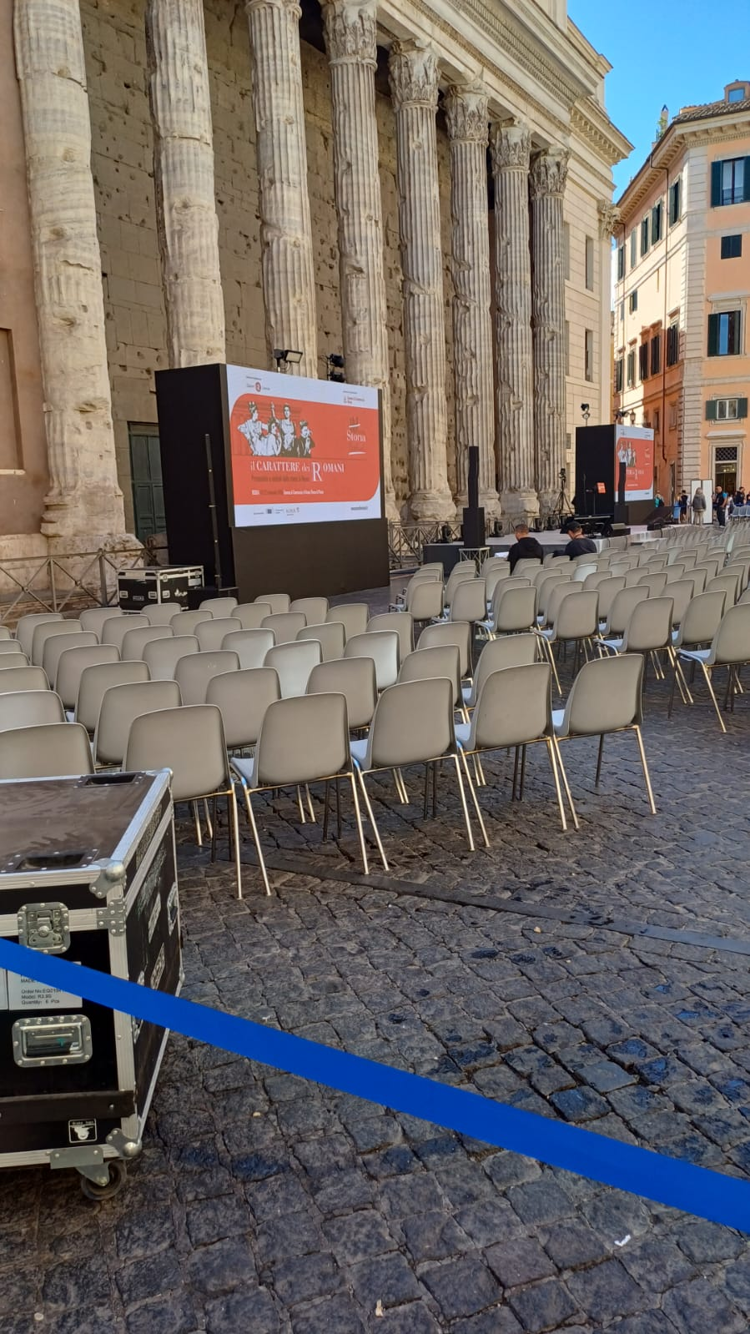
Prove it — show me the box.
[0,939,750,1231]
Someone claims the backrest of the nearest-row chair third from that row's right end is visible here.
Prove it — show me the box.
[366,676,455,768]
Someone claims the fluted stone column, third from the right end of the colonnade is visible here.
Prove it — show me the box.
[444,84,499,519]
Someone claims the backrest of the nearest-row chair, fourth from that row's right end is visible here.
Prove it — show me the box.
[252,694,351,787]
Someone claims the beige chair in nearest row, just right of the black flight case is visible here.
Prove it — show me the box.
[125,704,242,899]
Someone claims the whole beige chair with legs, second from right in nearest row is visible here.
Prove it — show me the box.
[456,663,568,847]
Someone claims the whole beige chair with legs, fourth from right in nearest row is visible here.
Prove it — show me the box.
[232,694,368,894]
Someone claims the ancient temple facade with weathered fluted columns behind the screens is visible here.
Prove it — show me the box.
[0,0,630,559]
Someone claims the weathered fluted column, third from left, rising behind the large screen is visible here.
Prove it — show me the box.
[246,0,318,376]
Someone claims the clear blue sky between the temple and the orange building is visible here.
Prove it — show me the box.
[567,0,750,199]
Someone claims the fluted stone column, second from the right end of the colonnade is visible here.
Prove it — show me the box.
[492,124,539,523]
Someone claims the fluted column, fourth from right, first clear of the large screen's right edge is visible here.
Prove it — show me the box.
[390,41,455,520]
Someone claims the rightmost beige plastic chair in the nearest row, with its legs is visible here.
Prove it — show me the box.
[552,653,657,815]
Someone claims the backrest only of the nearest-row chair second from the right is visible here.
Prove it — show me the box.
[468,663,552,750]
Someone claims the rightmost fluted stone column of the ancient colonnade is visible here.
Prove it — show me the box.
[531,148,571,515]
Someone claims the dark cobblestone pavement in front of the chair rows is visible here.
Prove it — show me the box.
[0,618,750,1334]
